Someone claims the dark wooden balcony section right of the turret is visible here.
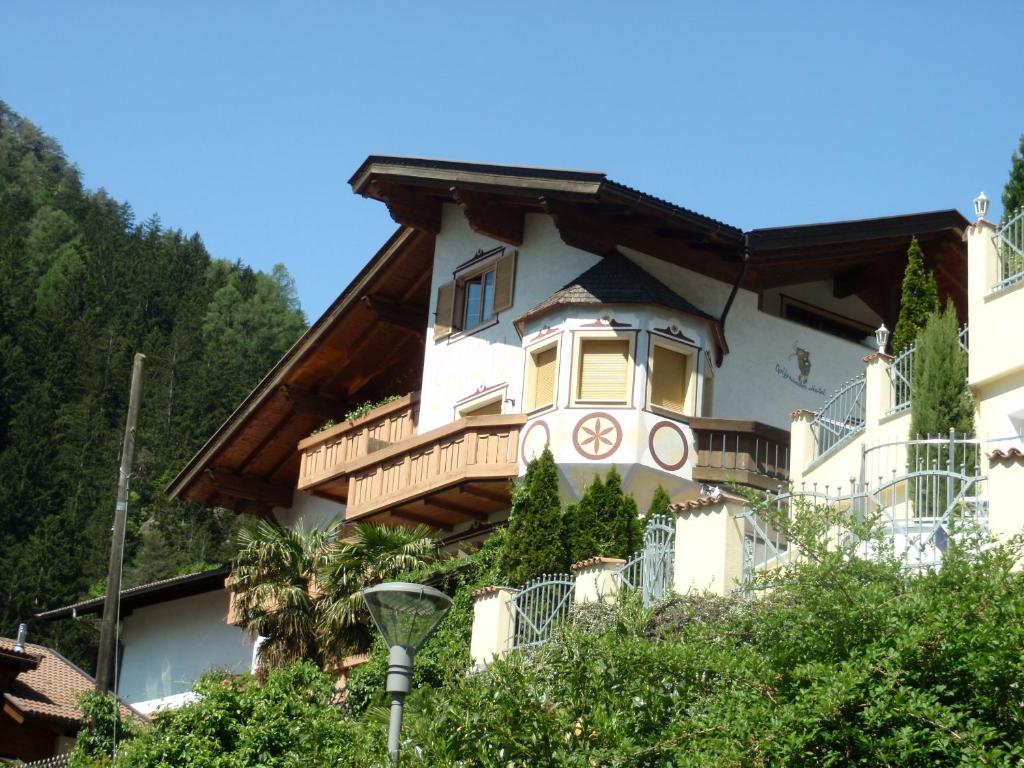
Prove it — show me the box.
[690,419,790,490]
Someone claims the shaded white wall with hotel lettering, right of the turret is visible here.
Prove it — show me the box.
[623,249,871,429]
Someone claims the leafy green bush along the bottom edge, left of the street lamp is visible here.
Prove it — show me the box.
[115,662,370,768]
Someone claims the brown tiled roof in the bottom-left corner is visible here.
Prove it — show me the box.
[0,638,142,730]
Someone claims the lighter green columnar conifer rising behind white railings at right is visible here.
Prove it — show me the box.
[910,302,974,437]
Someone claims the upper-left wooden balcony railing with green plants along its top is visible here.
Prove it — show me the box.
[297,392,420,501]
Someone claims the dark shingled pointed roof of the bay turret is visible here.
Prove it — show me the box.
[515,253,720,333]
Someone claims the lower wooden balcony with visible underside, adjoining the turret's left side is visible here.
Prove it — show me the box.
[346,414,526,528]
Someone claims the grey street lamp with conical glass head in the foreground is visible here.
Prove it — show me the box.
[362,582,452,767]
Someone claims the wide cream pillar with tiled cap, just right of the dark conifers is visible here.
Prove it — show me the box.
[671,494,748,595]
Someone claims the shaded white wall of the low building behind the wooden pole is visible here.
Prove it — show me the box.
[118,590,253,711]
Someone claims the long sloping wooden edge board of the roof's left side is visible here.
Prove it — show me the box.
[165,227,417,499]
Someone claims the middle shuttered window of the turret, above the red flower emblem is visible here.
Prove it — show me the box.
[572,333,636,406]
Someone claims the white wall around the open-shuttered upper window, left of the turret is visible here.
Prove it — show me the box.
[418,205,599,433]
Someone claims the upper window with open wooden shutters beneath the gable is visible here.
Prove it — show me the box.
[434,248,516,341]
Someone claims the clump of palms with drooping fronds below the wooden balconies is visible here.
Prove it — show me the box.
[230,518,437,671]
